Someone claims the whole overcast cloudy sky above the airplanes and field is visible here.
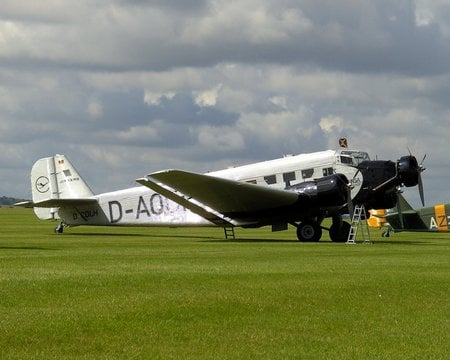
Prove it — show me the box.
[0,0,450,205]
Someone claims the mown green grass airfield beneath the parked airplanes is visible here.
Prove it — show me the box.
[0,208,450,359]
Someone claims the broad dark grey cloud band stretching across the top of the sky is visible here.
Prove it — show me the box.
[0,1,450,76]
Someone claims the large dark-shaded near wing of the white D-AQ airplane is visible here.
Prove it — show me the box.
[136,170,298,226]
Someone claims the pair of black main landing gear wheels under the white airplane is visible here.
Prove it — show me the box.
[294,217,351,242]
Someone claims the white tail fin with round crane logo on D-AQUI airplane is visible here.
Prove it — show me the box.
[31,155,94,220]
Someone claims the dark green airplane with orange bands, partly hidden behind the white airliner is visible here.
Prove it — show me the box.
[369,194,450,237]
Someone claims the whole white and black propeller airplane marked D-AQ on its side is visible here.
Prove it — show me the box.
[17,149,422,242]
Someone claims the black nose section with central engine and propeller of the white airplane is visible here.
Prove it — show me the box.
[354,155,424,209]
